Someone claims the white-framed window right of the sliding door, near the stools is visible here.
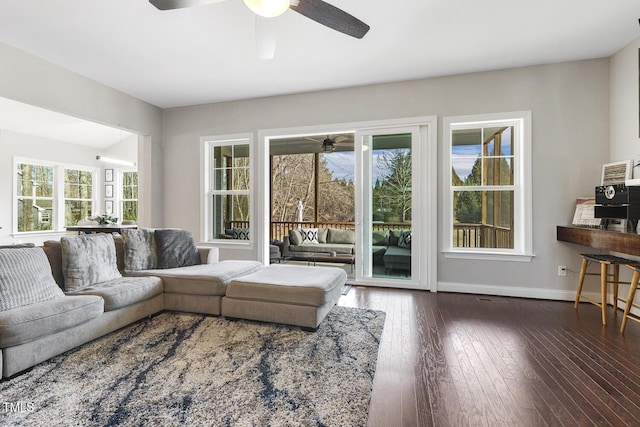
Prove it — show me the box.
[444,112,532,255]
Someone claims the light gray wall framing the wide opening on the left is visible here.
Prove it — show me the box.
[0,43,164,231]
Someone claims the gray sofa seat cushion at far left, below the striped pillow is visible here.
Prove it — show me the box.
[0,295,104,348]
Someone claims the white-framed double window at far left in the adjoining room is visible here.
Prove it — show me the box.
[14,160,96,233]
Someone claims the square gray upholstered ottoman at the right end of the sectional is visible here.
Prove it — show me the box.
[222,264,347,331]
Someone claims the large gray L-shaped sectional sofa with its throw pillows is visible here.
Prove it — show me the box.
[0,229,346,377]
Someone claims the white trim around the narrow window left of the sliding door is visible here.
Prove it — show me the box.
[200,133,256,249]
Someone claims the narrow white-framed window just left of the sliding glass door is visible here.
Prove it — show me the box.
[205,138,252,241]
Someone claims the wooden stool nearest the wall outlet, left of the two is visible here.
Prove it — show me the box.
[574,254,640,325]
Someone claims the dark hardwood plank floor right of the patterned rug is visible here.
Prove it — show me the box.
[339,287,640,427]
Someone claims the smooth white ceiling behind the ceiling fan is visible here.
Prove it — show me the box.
[0,0,640,108]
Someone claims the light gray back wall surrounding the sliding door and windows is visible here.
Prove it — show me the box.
[163,59,609,299]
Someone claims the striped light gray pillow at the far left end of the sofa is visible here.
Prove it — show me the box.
[0,248,64,311]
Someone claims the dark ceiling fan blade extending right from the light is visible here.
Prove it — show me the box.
[289,0,370,39]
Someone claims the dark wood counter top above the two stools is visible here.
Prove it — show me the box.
[556,225,640,256]
